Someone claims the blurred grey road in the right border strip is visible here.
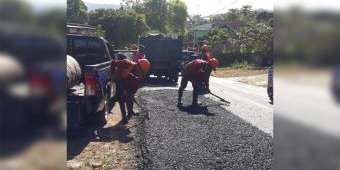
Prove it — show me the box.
[274,77,340,170]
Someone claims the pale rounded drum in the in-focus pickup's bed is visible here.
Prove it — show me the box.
[66,55,81,88]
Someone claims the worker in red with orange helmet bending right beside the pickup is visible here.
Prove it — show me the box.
[111,59,150,124]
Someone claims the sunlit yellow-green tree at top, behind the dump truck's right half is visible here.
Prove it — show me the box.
[169,0,188,35]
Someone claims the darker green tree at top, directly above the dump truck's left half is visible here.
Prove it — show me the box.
[145,0,168,33]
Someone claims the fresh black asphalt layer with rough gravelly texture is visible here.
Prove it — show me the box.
[136,89,273,170]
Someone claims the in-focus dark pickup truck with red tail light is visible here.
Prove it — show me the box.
[66,34,115,129]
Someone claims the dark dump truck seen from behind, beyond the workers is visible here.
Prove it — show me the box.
[139,34,183,82]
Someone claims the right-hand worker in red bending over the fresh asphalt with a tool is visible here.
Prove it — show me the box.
[177,58,219,107]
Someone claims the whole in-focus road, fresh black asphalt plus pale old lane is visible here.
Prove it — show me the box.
[136,78,273,169]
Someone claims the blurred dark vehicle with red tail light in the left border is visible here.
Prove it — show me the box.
[0,22,66,135]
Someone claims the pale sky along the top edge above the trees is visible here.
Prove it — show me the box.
[23,0,340,16]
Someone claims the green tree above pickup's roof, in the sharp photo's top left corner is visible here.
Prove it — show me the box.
[67,0,88,24]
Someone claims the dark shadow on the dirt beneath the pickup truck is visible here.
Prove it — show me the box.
[67,124,134,160]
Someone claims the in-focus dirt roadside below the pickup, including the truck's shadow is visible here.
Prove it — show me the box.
[67,104,139,170]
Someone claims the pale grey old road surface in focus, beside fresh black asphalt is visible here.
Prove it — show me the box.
[143,77,273,136]
